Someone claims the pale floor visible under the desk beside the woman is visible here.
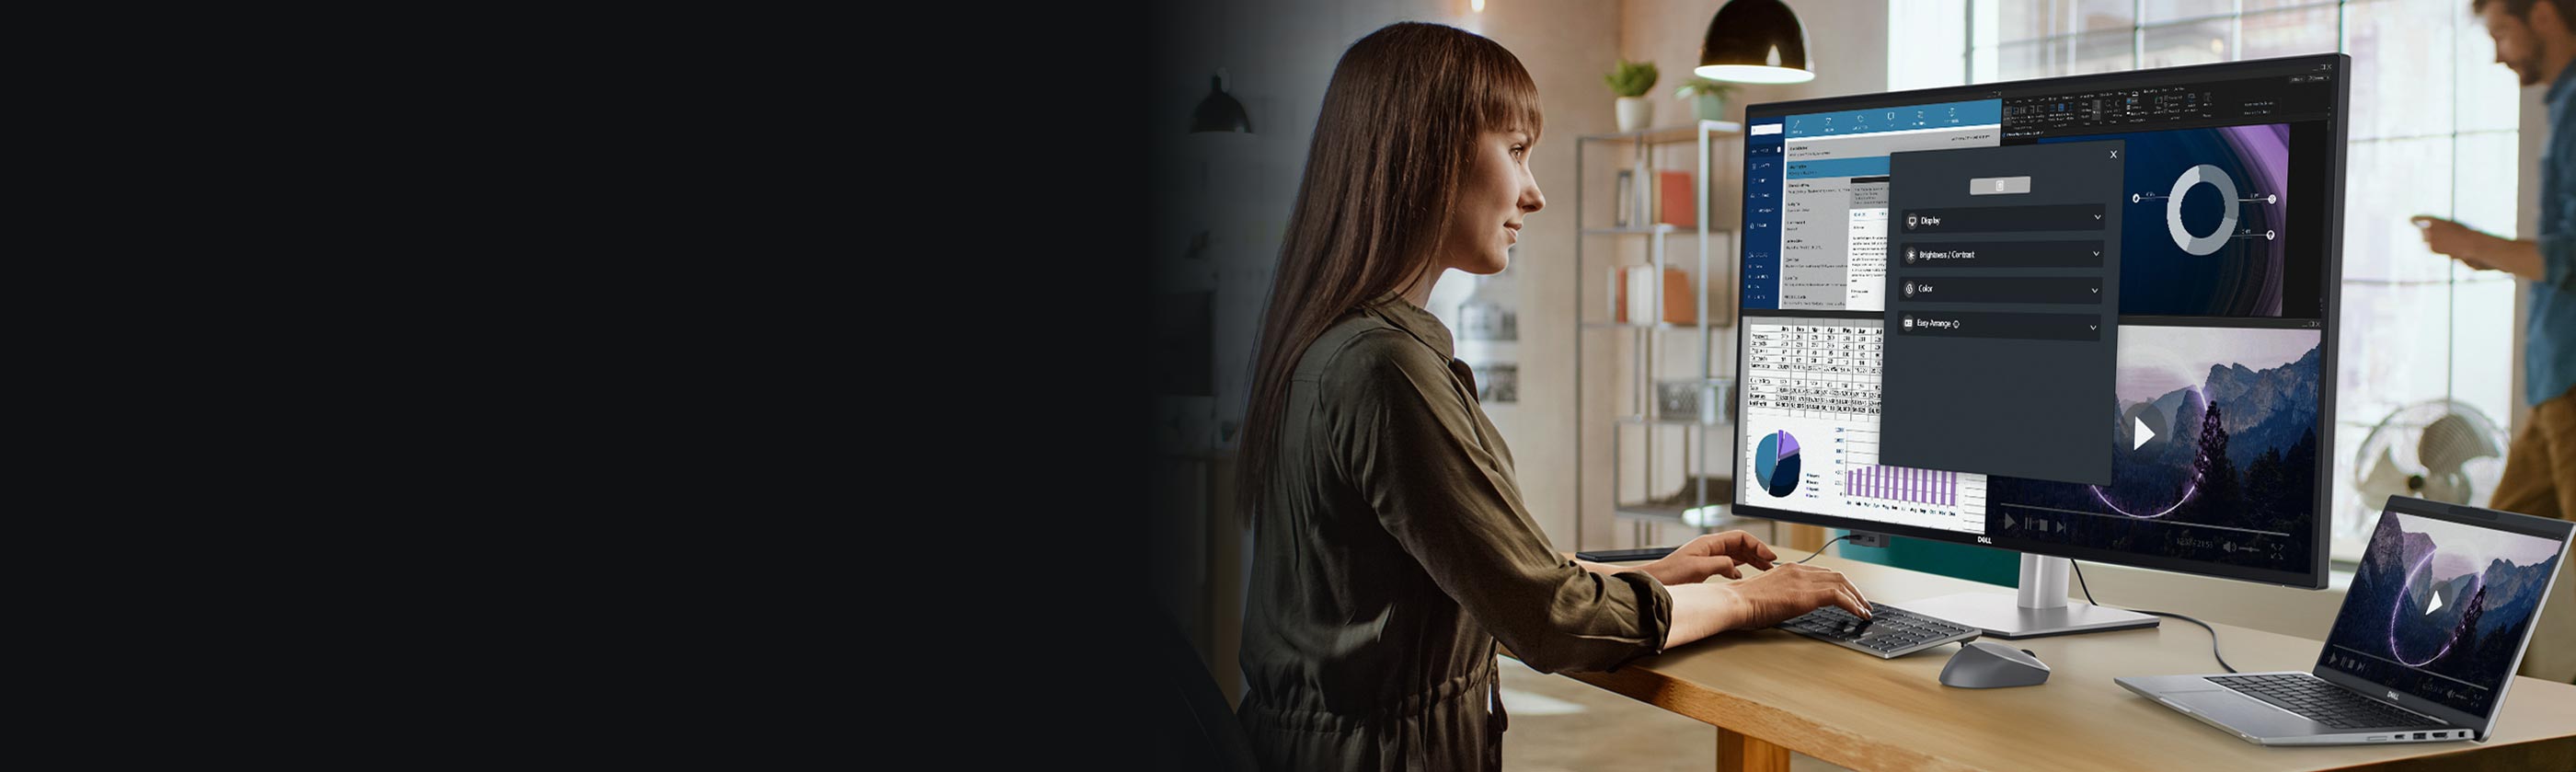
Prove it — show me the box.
[1501,656,1847,772]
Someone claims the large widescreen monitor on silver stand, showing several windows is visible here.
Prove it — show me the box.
[1733,54,2352,639]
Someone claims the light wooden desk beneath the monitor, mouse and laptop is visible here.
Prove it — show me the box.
[1566,556,2576,772]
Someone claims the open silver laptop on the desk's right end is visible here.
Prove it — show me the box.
[2118,497,2576,746]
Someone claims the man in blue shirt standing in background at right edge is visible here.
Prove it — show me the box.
[2416,0,2576,682]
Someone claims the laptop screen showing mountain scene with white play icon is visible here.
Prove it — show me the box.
[2318,510,2566,718]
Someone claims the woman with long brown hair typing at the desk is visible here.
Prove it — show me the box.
[1236,23,1868,769]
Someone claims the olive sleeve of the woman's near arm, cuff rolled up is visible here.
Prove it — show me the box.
[1324,329,1672,672]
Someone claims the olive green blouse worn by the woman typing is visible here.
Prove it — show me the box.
[1236,298,1672,769]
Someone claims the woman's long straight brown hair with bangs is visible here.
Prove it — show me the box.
[1236,20,1540,517]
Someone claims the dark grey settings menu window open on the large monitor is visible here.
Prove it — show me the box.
[1878,142,2128,484]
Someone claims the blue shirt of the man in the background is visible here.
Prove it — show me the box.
[2522,62,2576,404]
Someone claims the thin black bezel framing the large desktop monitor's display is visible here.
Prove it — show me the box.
[1729,54,2352,589]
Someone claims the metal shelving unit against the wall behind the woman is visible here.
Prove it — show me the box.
[1574,121,1744,548]
